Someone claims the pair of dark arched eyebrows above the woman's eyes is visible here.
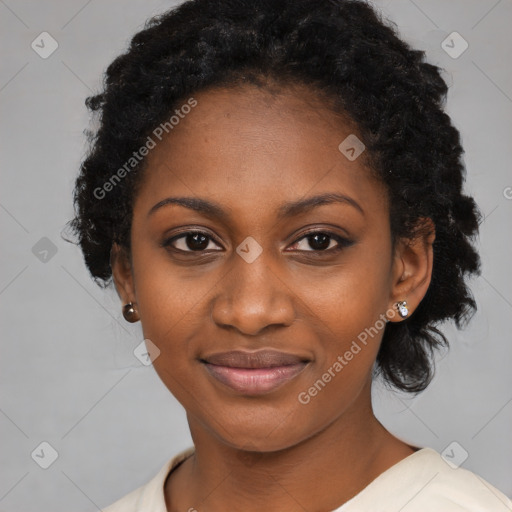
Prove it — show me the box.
[148,193,365,221]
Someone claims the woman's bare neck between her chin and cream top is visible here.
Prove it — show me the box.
[165,382,414,512]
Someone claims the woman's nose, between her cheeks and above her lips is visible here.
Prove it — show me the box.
[211,254,295,336]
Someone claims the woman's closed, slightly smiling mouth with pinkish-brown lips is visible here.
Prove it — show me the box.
[200,350,310,396]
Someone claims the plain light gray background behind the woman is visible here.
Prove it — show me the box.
[0,0,512,512]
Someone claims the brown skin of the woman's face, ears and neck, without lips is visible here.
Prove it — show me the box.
[112,85,434,512]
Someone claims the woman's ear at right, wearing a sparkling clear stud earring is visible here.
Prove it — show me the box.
[388,217,436,322]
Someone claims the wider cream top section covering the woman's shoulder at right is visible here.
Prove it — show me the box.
[338,448,512,512]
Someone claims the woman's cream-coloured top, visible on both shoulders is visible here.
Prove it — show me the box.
[103,448,512,512]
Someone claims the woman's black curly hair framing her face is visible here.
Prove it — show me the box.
[69,0,481,392]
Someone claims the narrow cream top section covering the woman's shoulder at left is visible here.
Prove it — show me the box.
[103,447,194,512]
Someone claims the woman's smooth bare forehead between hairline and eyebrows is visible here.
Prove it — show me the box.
[136,86,386,225]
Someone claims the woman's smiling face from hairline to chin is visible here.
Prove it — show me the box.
[116,86,408,451]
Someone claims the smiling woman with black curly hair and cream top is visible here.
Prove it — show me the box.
[72,0,512,512]
